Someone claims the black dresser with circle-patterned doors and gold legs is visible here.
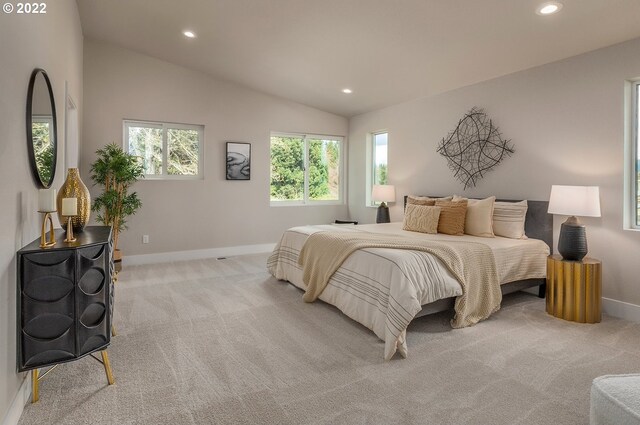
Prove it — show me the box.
[17,226,113,372]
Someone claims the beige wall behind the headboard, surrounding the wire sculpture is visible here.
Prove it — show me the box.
[349,39,640,305]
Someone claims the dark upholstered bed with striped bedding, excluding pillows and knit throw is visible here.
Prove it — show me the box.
[267,197,553,360]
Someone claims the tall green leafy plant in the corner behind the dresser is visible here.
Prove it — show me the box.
[91,143,144,260]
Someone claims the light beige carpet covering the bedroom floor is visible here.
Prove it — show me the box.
[20,254,640,425]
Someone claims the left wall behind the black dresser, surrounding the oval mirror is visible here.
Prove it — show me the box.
[0,0,82,423]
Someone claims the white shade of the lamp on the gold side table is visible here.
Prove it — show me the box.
[548,185,600,217]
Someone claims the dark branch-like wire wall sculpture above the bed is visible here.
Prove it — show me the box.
[438,107,515,189]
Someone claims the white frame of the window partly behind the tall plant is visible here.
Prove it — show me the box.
[122,119,204,180]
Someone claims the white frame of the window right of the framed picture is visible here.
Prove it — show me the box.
[269,131,347,207]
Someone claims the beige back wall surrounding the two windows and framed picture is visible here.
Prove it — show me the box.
[81,41,348,256]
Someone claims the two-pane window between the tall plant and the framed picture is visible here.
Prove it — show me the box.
[124,121,204,179]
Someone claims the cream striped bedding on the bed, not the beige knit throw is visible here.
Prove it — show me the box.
[268,223,549,359]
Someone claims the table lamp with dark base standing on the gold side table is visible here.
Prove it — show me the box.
[548,185,600,261]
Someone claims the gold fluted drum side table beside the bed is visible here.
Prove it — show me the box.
[547,255,602,323]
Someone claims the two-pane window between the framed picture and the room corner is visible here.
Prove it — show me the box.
[270,133,344,205]
